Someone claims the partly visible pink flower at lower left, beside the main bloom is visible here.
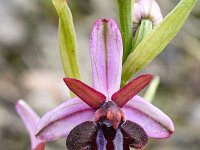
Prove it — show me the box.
[15,100,45,150]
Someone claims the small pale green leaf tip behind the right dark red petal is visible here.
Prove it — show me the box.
[144,76,160,102]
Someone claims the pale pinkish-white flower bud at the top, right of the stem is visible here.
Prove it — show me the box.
[132,0,163,26]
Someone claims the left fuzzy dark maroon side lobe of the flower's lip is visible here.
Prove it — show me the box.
[66,121,97,150]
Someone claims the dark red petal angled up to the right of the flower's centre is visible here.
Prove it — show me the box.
[111,74,153,107]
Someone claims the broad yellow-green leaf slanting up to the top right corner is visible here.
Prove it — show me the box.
[122,0,197,82]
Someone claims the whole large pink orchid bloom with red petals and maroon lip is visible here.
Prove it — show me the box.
[36,19,174,150]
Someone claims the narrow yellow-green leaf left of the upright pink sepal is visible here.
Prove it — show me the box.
[53,0,81,97]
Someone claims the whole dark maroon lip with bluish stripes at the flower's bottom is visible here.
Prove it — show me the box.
[66,118,148,150]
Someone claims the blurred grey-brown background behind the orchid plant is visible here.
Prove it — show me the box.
[0,0,200,150]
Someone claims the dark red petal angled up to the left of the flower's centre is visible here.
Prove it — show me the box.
[63,78,106,109]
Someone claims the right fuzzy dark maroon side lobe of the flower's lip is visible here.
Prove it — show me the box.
[121,120,148,150]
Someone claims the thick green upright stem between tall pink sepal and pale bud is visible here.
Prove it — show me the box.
[117,0,134,62]
